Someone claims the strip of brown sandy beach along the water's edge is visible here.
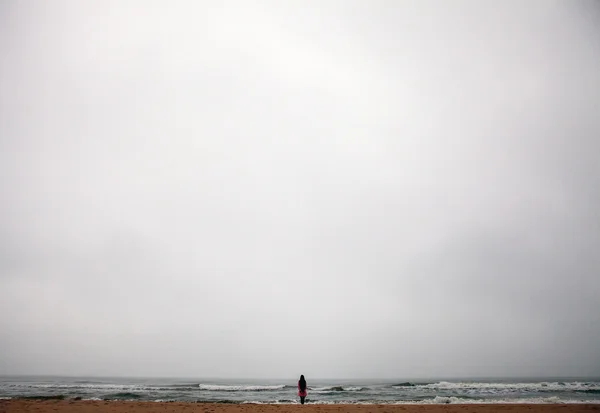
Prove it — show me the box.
[0,400,600,413]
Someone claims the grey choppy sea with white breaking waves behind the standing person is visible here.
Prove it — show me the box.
[0,376,600,404]
